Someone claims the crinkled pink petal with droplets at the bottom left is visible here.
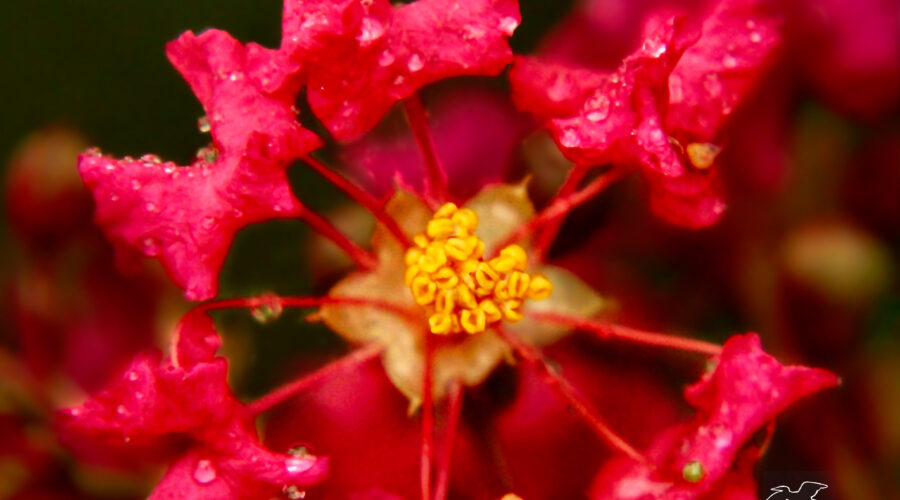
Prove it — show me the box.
[58,312,327,500]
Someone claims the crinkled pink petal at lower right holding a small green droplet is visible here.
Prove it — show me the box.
[592,334,838,500]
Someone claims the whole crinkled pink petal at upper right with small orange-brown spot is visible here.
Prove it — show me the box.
[510,0,781,227]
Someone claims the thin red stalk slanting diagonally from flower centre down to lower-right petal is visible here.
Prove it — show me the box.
[497,328,647,462]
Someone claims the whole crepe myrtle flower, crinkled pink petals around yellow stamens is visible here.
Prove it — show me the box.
[60,0,837,500]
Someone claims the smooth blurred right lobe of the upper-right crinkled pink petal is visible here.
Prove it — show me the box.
[665,0,782,142]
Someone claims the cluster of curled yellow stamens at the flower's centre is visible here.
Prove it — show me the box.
[404,203,553,335]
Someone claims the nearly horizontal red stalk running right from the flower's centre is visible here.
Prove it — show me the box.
[529,313,722,356]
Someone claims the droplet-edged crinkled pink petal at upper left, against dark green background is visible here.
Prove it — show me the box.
[79,30,319,300]
